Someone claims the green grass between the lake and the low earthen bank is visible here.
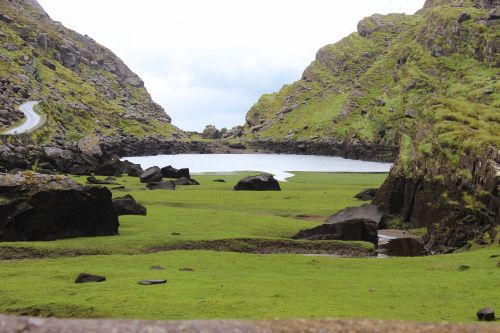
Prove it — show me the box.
[0,173,386,253]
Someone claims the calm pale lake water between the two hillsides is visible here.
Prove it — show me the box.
[123,154,392,181]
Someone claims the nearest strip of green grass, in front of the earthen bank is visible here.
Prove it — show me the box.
[0,246,500,322]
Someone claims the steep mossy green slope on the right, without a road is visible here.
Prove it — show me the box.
[245,0,500,251]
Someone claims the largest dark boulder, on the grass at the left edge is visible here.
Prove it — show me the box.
[0,172,119,241]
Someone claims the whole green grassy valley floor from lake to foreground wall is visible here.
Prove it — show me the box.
[0,173,500,322]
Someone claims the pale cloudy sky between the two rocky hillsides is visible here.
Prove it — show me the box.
[39,0,425,131]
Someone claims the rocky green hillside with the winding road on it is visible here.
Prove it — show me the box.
[0,0,178,143]
